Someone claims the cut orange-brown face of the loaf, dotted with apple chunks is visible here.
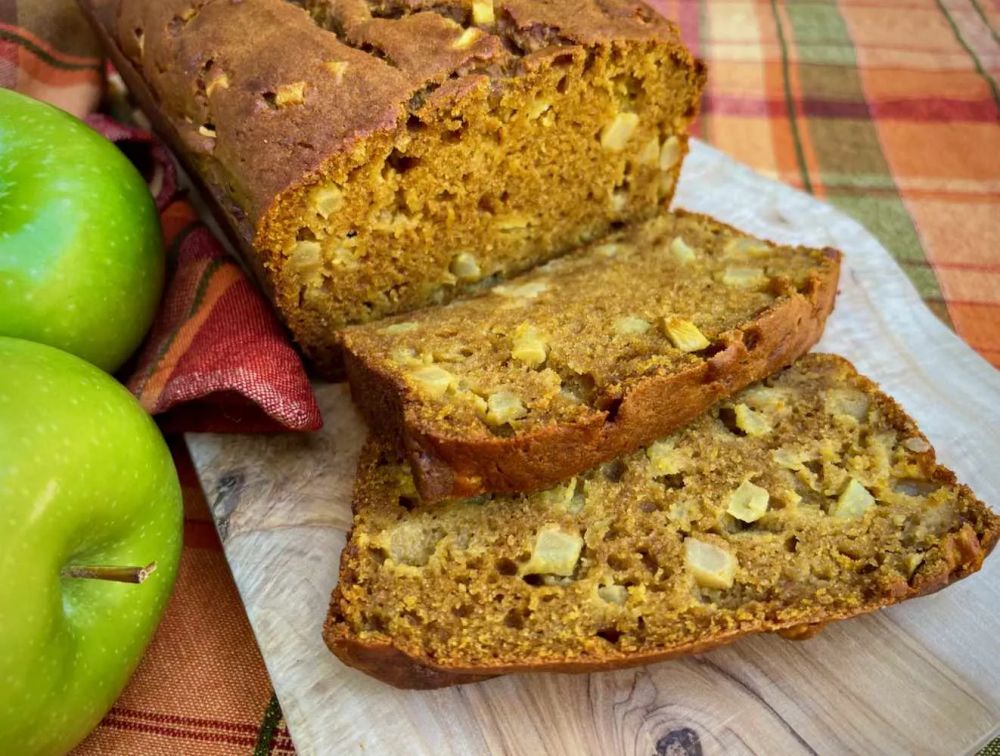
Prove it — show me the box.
[273,43,701,372]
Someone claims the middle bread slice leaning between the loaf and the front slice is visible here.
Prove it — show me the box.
[342,212,840,501]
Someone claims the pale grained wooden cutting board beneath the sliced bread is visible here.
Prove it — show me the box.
[189,143,1000,756]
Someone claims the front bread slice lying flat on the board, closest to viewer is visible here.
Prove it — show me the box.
[324,355,1000,688]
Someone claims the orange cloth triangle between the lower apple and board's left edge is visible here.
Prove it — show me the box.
[74,438,294,756]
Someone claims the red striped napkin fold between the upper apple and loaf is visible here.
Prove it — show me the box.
[87,115,322,432]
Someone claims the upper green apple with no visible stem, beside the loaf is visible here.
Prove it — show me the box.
[0,89,164,372]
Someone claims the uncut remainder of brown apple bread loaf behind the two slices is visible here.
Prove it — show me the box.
[85,0,704,372]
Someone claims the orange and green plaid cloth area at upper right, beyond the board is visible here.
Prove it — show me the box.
[651,0,1000,367]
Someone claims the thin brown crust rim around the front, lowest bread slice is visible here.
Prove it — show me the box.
[323,355,1000,688]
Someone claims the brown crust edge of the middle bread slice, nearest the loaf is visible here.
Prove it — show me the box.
[345,210,840,501]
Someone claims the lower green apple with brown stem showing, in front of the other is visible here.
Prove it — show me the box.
[0,337,183,755]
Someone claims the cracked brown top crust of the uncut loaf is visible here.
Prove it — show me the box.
[111,0,695,237]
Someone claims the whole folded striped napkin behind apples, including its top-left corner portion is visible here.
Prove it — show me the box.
[0,0,322,432]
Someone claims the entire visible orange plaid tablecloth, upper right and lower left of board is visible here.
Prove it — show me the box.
[52,0,1000,755]
